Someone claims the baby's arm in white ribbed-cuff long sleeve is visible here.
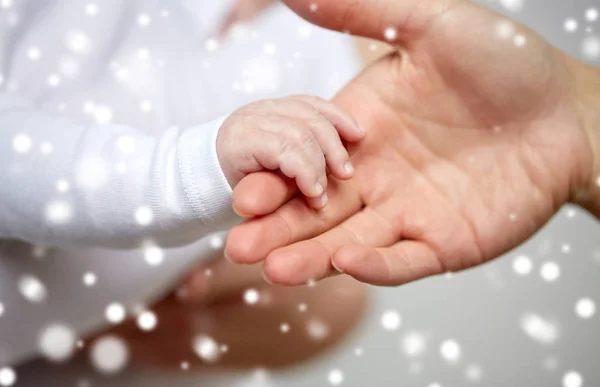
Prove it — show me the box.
[0,95,235,248]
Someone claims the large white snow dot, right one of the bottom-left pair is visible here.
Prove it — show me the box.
[90,336,129,375]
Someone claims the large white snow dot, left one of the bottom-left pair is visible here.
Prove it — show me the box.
[38,324,77,363]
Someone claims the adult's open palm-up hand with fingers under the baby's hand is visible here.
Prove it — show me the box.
[226,0,599,285]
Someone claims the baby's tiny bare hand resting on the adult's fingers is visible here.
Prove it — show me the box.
[217,96,364,209]
